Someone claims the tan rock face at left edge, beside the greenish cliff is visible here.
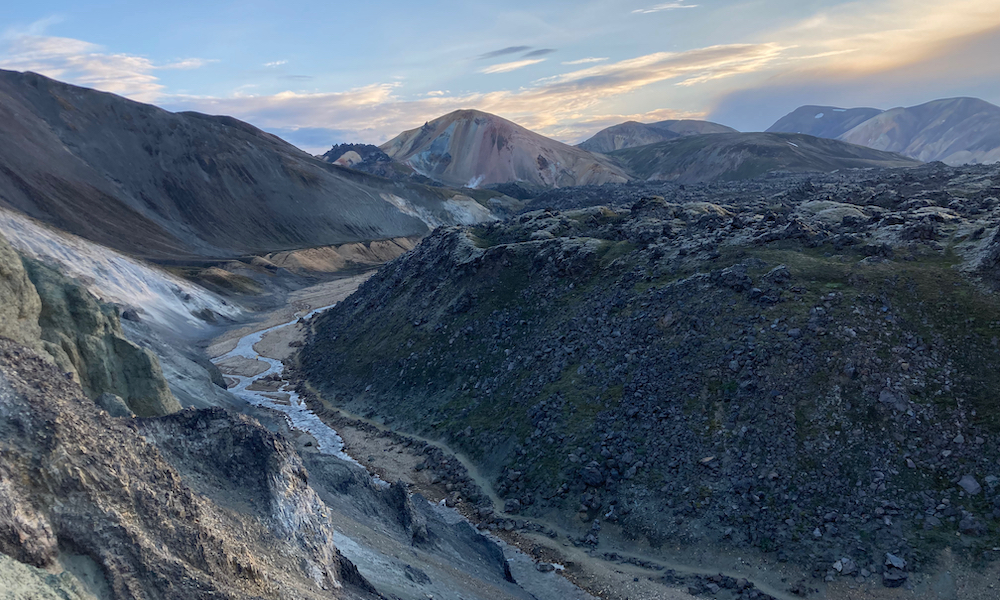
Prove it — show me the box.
[0,236,42,351]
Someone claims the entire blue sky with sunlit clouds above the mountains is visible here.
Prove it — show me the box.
[0,0,1000,153]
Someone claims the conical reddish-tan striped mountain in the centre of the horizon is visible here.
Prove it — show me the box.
[381,110,628,187]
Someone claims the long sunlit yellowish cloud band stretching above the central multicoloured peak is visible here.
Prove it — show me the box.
[168,44,782,153]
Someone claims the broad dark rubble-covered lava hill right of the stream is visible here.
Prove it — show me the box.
[300,165,1000,585]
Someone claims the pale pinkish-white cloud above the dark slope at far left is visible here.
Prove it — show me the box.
[0,26,213,102]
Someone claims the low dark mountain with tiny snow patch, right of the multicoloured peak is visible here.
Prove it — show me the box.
[608,133,919,183]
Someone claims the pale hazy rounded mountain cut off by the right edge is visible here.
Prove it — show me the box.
[840,98,1000,165]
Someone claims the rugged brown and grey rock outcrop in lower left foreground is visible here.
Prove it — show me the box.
[0,340,377,600]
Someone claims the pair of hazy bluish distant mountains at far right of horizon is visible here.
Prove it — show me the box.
[768,98,1000,165]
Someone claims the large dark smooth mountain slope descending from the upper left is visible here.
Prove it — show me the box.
[0,71,500,259]
